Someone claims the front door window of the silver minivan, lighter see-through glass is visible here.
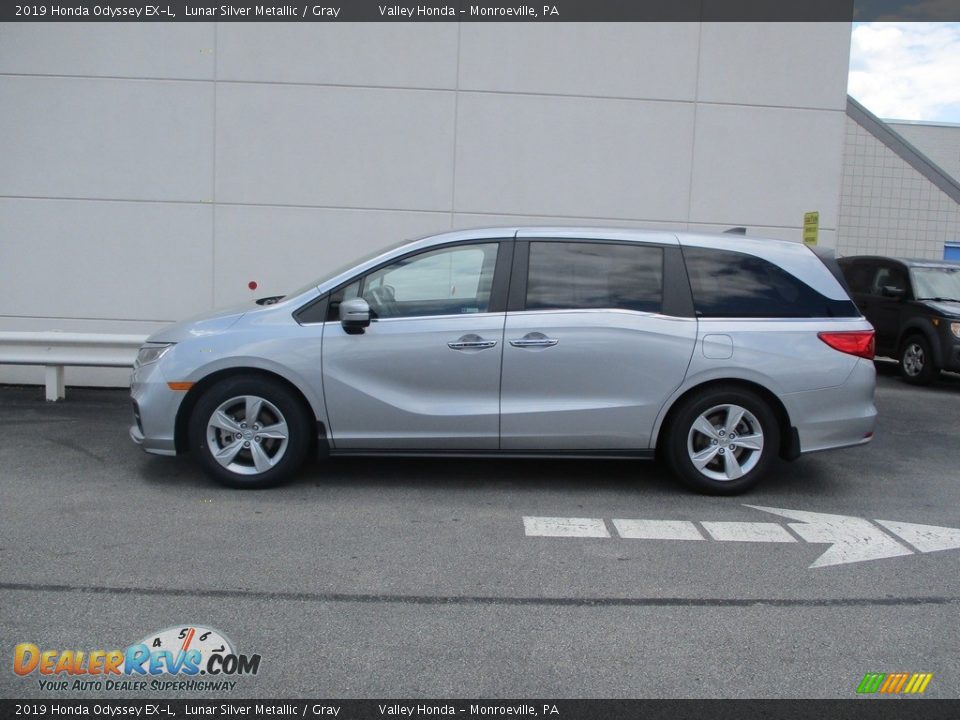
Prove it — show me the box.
[327,242,499,320]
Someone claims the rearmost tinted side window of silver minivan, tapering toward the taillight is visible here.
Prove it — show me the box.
[683,248,859,318]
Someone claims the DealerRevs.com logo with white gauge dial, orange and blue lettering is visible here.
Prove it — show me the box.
[13,625,260,691]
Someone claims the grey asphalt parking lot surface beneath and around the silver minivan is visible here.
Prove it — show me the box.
[0,364,960,698]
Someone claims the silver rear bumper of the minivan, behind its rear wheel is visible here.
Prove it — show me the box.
[783,359,877,453]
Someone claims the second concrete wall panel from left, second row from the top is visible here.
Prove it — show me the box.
[217,84,454,211]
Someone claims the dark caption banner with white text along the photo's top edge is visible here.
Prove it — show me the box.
[9,0,944,22]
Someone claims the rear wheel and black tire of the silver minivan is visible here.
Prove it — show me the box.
[664,385,780,495]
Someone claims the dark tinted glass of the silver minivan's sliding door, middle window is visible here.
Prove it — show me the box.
[527,242,663,312]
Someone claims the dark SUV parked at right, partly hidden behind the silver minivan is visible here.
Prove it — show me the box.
[839,255,960,385]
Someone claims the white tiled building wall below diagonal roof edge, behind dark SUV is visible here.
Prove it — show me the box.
[837,118,960,259]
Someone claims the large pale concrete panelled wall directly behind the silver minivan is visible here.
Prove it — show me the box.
[0,23,850,383]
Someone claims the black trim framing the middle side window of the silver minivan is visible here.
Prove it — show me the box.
[507,237,696,318]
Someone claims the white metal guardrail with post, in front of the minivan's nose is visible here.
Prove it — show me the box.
[0,332,147,401]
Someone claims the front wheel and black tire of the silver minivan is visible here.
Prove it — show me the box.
[188,375,314,489]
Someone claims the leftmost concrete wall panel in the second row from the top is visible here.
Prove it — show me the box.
[0,76,213,202]
